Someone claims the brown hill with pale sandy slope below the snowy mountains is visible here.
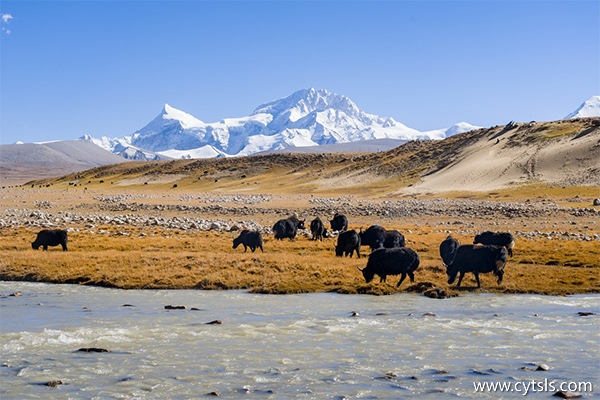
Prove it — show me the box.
[23,118,600,195]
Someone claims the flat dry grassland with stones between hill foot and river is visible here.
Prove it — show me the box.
[0,182,600,295]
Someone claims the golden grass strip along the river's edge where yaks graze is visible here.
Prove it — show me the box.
[0,227,600,295]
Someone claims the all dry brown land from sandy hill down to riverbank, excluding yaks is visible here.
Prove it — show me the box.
[0,118,600,295]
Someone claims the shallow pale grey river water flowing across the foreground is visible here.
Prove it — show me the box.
[0,282,600,400]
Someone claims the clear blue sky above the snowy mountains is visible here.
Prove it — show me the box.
[0,0,600,144]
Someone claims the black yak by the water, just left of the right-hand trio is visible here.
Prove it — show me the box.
[359,247,420,287]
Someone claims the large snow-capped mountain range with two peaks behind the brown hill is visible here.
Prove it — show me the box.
[87,88,479,158]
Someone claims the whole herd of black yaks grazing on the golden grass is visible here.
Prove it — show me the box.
[31,214,515,287]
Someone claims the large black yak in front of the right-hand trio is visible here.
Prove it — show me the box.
[446,244,507,288]
